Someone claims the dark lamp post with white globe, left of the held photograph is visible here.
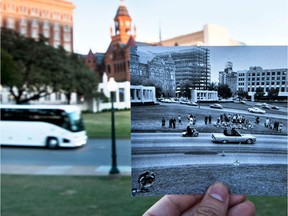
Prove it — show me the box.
[107,77,120,174]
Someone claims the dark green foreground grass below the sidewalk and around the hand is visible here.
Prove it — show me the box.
[1,175,287,216]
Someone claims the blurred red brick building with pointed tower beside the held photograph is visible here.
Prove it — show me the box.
[85,4,148,82]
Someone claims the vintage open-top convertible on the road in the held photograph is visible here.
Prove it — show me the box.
[212,133,256,144]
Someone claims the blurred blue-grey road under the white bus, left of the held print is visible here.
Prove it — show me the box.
[1,139,131,166]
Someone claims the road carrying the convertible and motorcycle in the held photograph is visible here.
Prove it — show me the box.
[131,133,287,168]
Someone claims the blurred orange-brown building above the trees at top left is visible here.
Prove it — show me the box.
[0,0,75,52]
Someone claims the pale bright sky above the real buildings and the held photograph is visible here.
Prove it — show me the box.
[72,0,288,80]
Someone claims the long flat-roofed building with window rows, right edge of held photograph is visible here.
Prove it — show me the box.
[237,66,288,97]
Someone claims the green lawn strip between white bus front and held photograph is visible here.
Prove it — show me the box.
[83,110,130,139]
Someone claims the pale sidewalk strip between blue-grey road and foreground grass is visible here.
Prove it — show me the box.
[1,164,131,176]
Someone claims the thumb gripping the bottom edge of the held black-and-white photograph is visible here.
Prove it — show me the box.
[195,182,229,216]
